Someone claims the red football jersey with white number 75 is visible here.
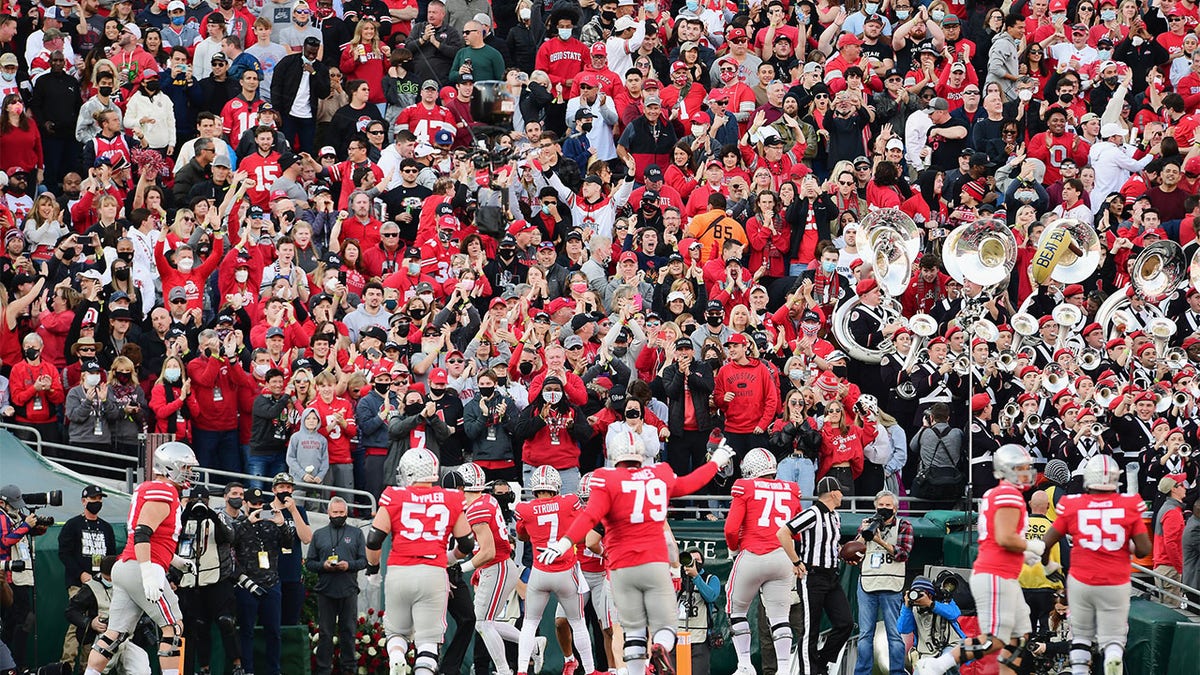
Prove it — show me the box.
[725,478,800,555]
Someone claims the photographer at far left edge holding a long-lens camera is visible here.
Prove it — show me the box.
[0,485,49,668]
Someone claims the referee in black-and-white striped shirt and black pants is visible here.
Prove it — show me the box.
[779,476,854,675]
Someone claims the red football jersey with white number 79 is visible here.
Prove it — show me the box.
[569,464,678,569]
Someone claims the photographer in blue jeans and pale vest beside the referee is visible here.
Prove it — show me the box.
[854,490,912,675]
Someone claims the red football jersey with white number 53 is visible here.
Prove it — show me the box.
[379,485,463,567]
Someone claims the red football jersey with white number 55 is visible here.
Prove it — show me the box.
[1052,492,1146,586]
